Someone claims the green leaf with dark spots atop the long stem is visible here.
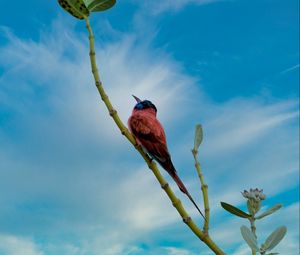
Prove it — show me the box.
[58,0,90,19]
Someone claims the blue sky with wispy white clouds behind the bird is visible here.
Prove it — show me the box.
[0,0,299,255]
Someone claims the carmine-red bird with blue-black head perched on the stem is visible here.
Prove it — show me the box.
[128,96,205,219]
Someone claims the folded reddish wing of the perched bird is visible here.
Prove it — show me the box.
[128,115,170,163]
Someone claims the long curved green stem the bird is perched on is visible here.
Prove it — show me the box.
[85,17,225,255]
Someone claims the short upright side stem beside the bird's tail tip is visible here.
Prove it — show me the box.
[192,149,210,235]
